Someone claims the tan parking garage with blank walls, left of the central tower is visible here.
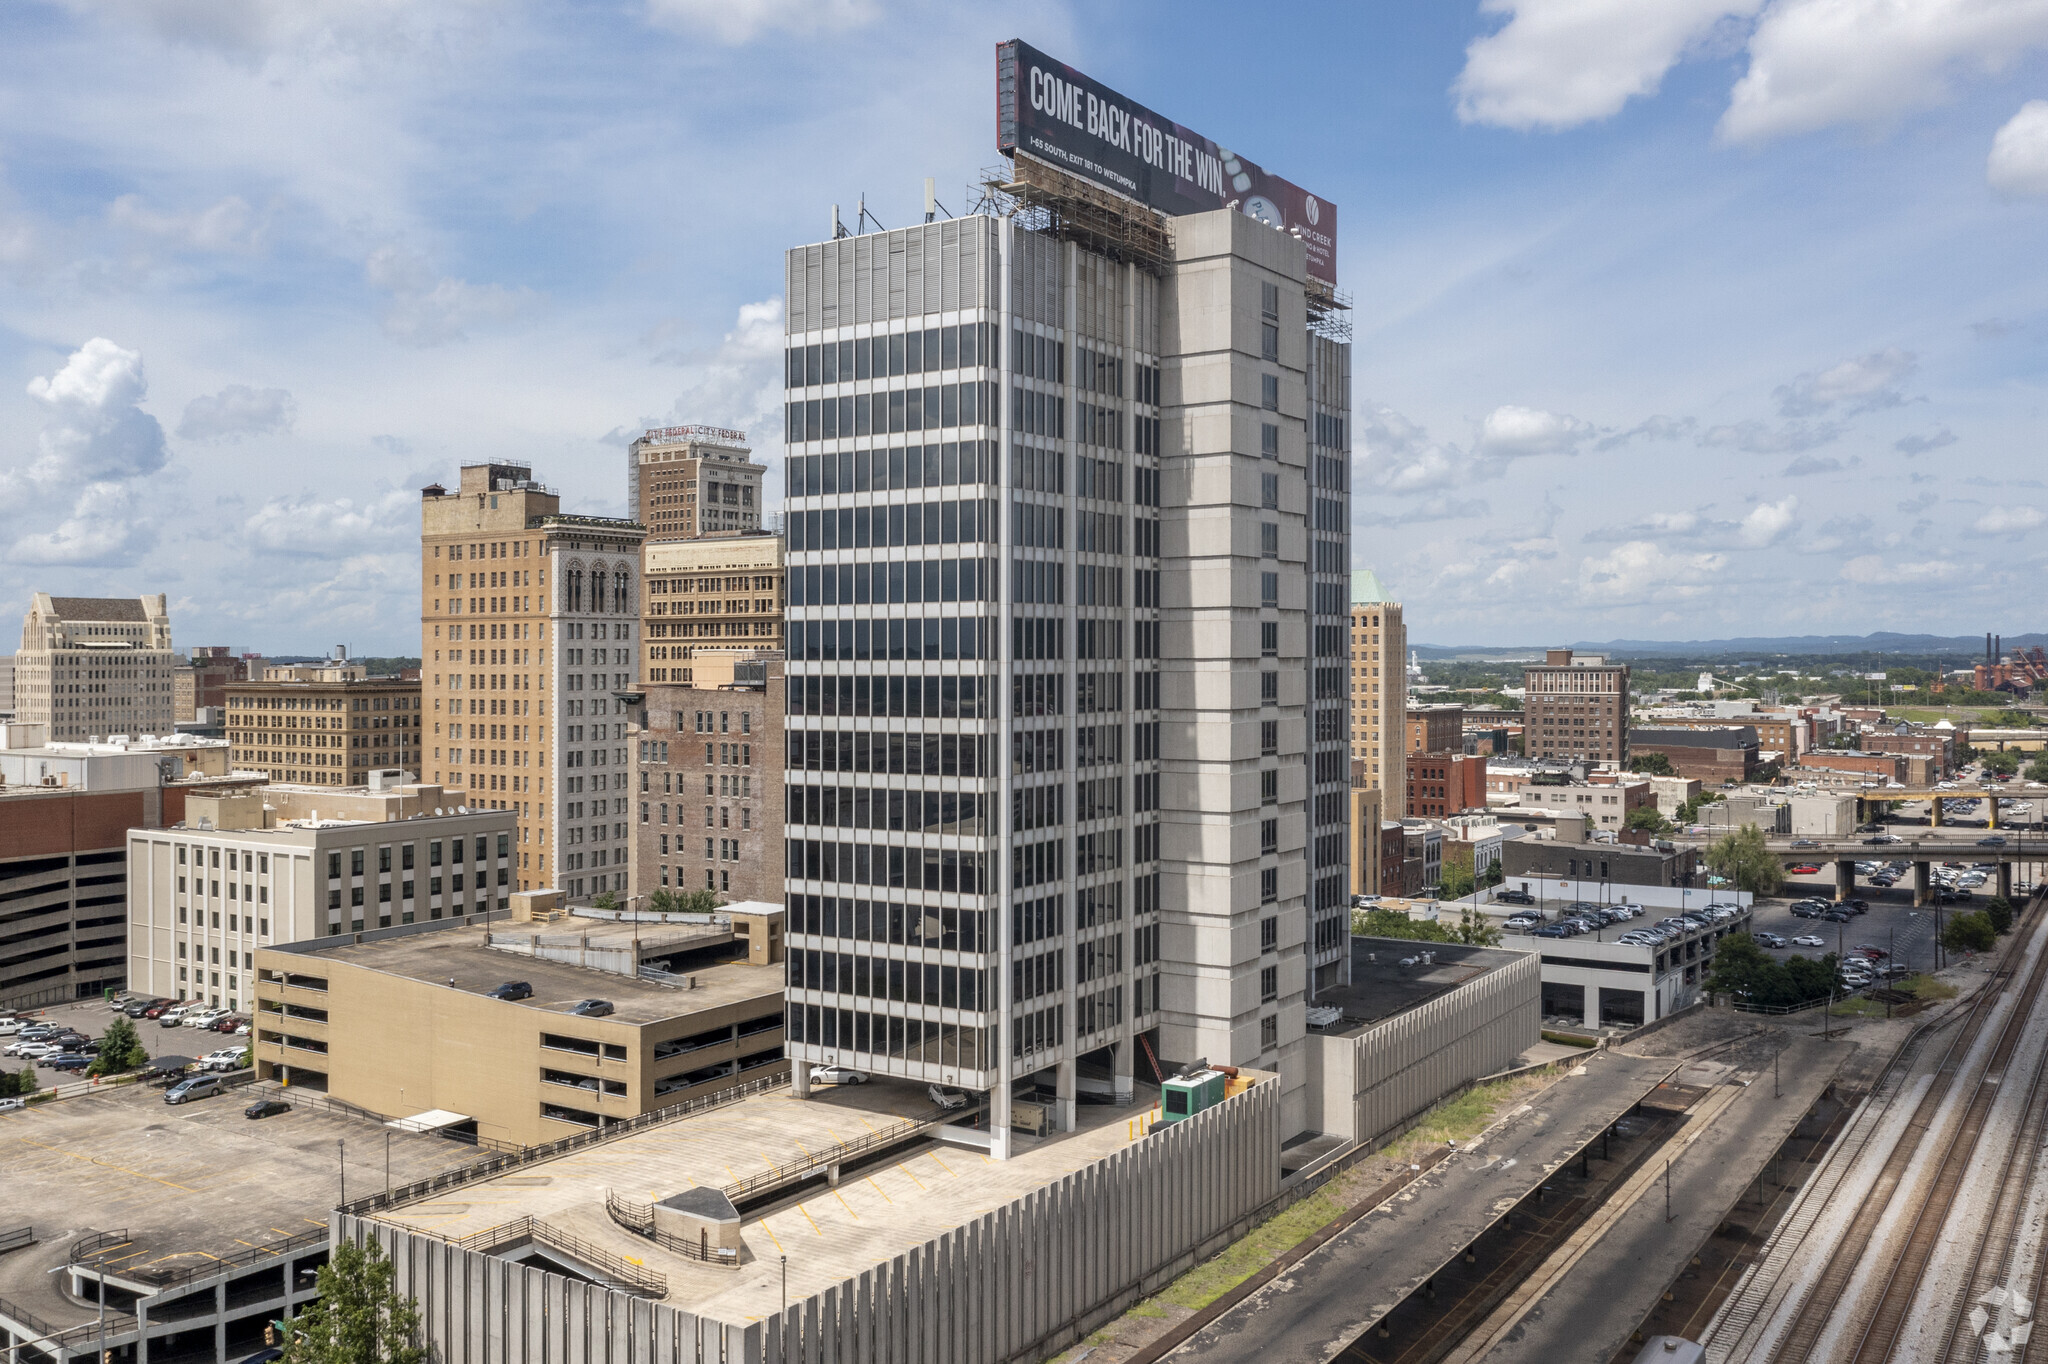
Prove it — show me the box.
[254,891,788,1147]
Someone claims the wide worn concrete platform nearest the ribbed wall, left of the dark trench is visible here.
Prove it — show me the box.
[1165,1051,1677,1364]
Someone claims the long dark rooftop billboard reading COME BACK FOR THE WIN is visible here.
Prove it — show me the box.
[995,39,1337,285]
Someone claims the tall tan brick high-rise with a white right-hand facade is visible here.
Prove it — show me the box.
[416,463,647,897]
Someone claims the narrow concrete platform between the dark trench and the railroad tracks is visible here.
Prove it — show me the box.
[1481,1036,1855,1364]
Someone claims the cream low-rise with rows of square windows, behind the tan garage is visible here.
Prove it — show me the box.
[127,786,512,1010]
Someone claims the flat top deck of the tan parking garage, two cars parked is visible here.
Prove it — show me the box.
[293,918,782,1024]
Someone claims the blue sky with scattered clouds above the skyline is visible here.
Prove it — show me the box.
[0,0,2048,653]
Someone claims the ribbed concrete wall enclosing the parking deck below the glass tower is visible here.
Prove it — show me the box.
[336,1079,1282,1364]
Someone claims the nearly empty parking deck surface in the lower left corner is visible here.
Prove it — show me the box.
[0,1085,477,1327]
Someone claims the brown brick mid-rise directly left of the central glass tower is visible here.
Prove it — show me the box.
[626,657,778,903]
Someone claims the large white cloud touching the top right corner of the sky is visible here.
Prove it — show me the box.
[1720,0,2048,141]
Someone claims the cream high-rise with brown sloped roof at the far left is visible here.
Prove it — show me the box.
[14,592,180,741]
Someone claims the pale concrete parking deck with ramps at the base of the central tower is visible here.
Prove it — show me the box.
[373,1077,1171,1321]
